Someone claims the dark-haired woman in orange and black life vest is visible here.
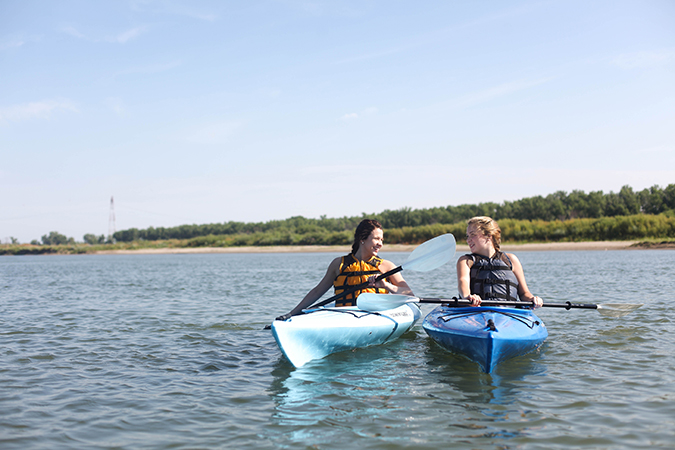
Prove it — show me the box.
[277,219,412,320]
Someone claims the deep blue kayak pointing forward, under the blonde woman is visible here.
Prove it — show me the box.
[422,306,548,373]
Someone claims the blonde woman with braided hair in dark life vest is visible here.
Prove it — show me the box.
[457,216,543,308]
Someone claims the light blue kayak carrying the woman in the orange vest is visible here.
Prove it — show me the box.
[272,304,422,367]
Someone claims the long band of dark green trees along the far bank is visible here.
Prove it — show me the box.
[112,184,675,246]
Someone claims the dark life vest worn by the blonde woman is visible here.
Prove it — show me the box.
[466,252,518,301]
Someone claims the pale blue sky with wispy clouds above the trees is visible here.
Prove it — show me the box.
[0,0,675,243]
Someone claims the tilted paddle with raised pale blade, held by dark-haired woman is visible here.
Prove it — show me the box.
[308,233,456,309]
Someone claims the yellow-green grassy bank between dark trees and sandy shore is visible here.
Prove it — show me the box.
[5,214,675,255]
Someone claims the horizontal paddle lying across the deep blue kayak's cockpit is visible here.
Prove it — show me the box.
[356,292,642,317]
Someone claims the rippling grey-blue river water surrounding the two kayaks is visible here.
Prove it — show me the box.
[0,250,675,449]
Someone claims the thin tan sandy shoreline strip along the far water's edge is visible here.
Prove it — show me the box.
[92,241,644,255]
